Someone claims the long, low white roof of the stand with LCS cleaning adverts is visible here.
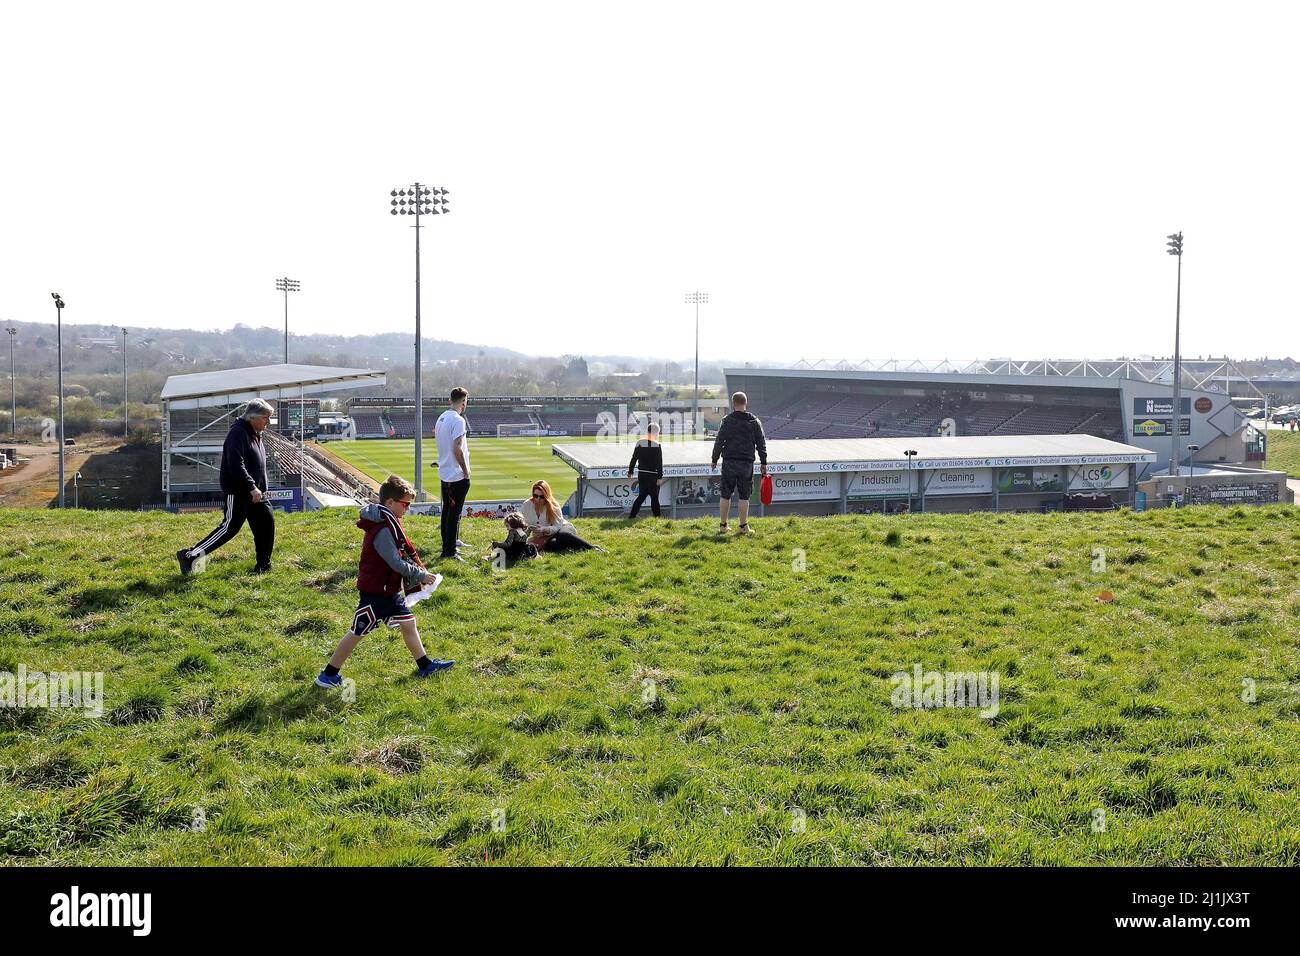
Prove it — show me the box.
[551,434,1157,477]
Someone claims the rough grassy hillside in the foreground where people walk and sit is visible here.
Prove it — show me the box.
[0,506,1300,866]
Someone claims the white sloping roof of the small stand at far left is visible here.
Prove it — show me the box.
[161,364,387,408]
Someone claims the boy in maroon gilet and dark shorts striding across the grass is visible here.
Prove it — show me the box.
[316,475,455,689]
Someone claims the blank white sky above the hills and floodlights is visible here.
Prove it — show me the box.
[0,0,1300,362]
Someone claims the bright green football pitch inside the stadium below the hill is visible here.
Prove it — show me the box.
[322,436,655,502]
